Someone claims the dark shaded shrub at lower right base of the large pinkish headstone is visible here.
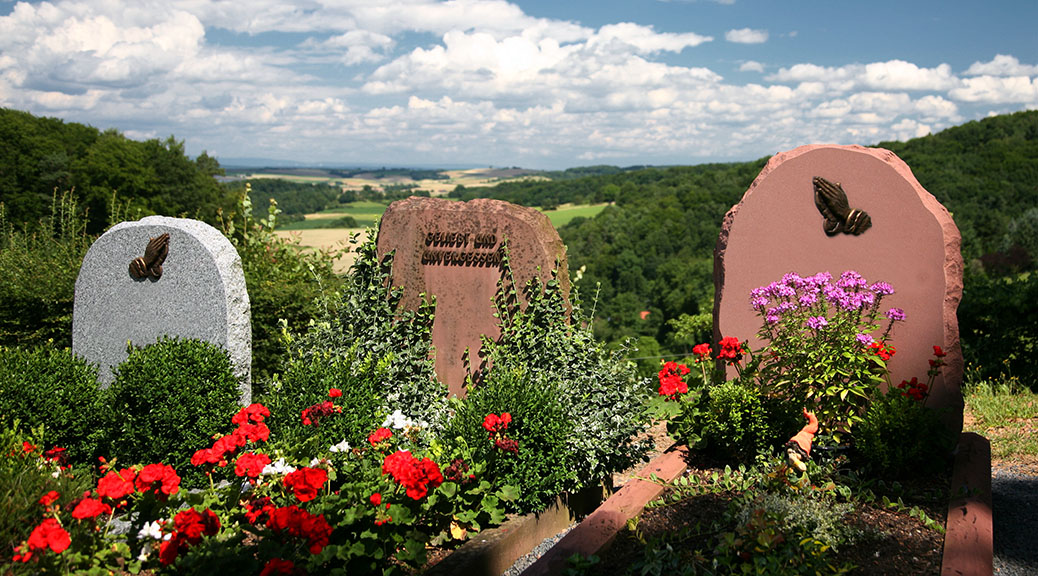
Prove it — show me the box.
[852,388,955,477]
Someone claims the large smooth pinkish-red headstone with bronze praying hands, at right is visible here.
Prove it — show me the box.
[714,145,962,430]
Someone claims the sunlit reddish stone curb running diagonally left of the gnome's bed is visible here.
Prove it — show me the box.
[522,444,688,576]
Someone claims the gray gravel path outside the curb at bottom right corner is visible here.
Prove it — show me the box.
[991,465,1038,576]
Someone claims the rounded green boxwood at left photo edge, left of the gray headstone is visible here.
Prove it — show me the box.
[0,348,109,463]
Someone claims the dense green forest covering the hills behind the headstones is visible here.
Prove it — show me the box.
[0,109,1038,388]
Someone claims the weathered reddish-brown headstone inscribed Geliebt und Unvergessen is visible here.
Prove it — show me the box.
[378,197,569,395]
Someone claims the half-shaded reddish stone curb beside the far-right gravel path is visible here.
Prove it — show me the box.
[940,432,994,576]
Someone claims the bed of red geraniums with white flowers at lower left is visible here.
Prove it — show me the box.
[6,390,515,574]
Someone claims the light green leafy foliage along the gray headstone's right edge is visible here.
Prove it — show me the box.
[221,184,340,386]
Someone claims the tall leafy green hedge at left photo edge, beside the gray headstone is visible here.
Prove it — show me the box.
[0,193,93,348]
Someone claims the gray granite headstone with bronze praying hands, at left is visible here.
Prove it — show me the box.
[72,216,252,403]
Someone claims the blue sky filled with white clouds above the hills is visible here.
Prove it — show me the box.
[0,0,1038,168]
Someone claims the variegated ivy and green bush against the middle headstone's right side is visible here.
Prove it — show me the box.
[444,267,648,510]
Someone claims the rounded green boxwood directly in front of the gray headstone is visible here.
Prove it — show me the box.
[100,338,241,487]
